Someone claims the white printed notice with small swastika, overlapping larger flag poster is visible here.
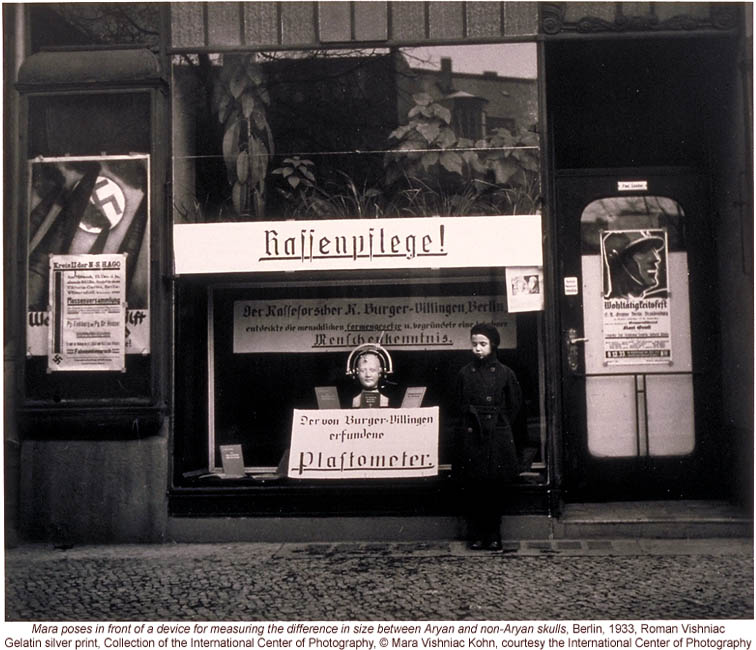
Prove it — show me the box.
[48,254,126,371]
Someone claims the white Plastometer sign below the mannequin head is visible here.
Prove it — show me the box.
[288,406,438,479]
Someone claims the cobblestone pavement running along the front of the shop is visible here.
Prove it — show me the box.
[5,539,754,621]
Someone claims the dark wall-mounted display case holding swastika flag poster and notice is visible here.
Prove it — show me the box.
[17,50,170,436]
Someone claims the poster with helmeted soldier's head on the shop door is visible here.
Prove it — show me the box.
[601,228,672,365]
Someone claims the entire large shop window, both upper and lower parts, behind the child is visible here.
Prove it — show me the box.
[173,44,546,485]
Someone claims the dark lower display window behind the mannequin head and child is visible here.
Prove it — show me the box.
[201,273,539,471]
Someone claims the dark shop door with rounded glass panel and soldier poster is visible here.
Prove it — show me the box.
[557,170,724,501]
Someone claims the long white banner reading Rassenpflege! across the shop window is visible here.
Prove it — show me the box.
[173,215,542,275]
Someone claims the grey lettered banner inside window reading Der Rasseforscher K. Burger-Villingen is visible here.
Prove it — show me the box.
[234,296,517,353]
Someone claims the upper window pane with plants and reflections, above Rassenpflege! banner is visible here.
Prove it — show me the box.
[173,43,540,223]
